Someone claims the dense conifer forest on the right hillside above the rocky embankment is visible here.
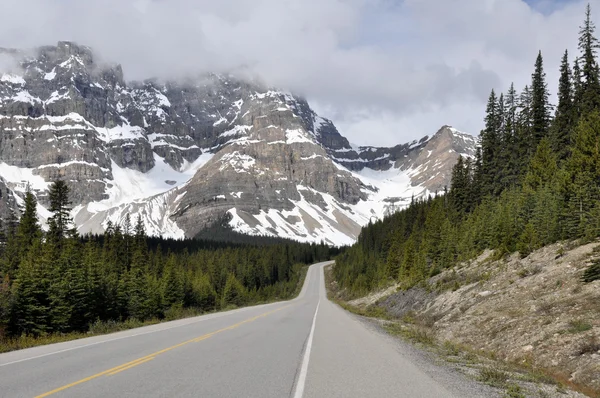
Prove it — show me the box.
[335,5,600,295]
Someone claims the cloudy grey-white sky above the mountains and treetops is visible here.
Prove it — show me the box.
[0,0,600,145]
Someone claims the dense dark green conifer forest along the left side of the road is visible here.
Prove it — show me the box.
[0,180,336,343]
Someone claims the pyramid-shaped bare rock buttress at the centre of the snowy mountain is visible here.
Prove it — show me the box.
[174,93,366,236]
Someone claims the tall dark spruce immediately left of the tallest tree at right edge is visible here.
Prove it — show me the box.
[551,51,575,161]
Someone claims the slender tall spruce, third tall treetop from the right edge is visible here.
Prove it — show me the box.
[528,51,551,148]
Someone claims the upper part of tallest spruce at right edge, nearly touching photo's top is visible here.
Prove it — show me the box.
[579,4,600,114]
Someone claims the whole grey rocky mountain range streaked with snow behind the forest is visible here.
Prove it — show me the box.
[0,42,476,244]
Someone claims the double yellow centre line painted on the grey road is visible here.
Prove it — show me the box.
[35,304,291,398]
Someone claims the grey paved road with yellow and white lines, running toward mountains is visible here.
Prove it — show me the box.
[0,263,490,398]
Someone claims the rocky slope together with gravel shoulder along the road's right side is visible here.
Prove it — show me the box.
[326,249,600,398]
